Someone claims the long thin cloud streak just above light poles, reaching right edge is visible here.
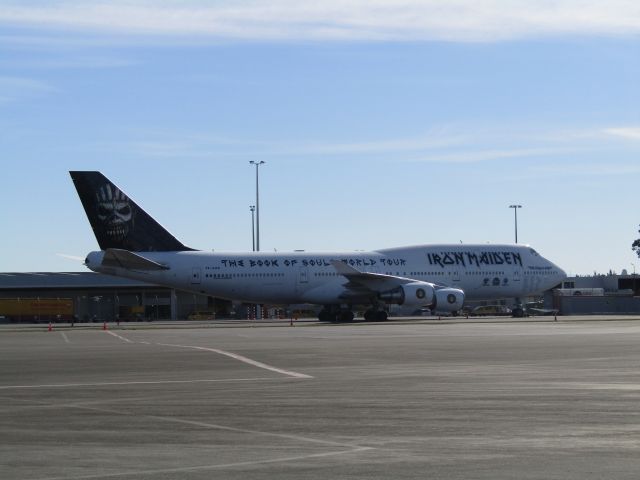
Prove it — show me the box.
[127,122,640,163]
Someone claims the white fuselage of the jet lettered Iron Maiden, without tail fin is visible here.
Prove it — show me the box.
[86,244,566,305]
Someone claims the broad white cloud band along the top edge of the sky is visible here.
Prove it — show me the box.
[0,0,640,42]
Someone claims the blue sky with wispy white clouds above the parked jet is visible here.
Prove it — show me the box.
[0,0,640,274]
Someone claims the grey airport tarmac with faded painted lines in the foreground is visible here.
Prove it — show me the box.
[0,317,640,480]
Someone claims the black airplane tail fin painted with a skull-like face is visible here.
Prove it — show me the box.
[69,172,193,252]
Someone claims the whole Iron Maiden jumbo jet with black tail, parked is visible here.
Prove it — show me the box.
[69,171,566,321]
